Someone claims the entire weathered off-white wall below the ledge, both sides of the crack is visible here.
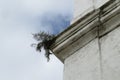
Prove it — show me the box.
[64,26,120,80]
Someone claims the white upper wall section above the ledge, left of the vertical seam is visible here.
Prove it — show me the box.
[73,0,93,22]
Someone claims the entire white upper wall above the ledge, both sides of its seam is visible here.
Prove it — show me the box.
[71,0,109,23]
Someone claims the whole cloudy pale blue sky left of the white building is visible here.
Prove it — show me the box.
[0,0,73,80]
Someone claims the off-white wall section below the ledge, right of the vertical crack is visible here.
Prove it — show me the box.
[100,26,120,80]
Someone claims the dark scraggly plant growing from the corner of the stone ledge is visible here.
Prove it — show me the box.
[32,31,55,61]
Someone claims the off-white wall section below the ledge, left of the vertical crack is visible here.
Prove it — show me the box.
[64,39,100,80]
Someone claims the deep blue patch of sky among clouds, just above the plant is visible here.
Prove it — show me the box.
[38,13,70,34]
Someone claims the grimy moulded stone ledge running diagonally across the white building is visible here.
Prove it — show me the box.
[51,0,120,63]
